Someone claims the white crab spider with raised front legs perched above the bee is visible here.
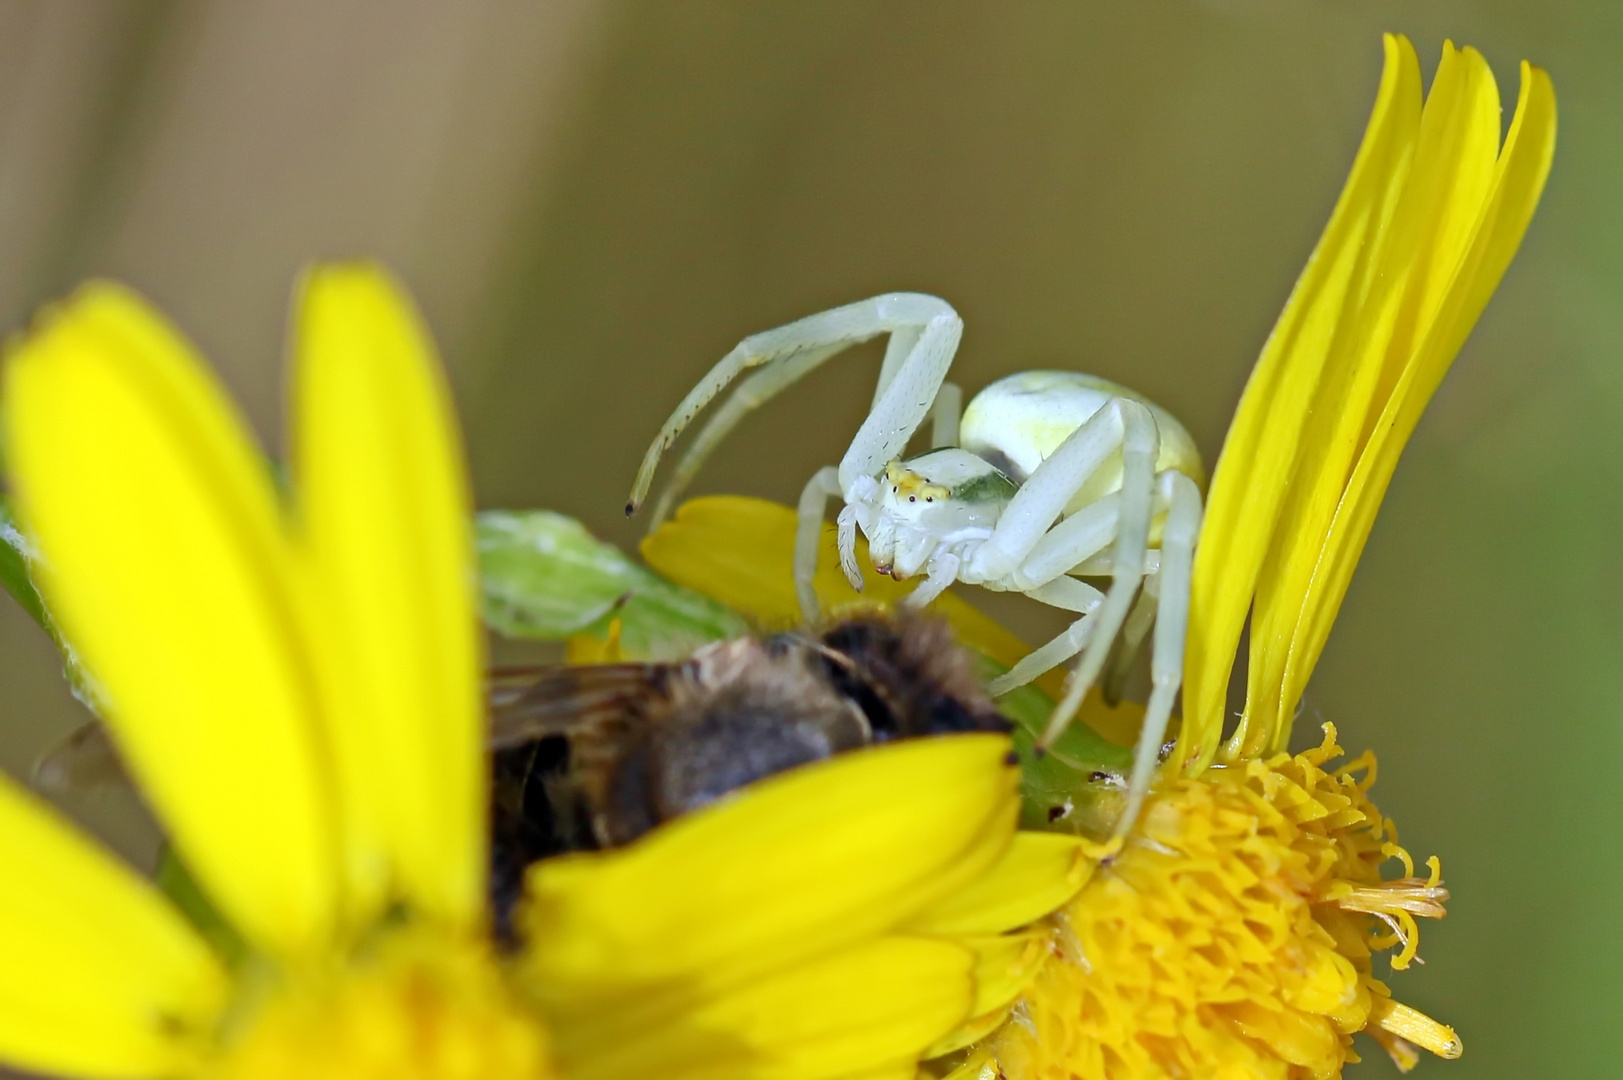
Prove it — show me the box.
[626,292,1204,833]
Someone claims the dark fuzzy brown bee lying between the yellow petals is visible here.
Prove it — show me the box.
[492,614,1010,929]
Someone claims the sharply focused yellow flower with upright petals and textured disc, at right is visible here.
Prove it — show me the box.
[954,36,1555,1080]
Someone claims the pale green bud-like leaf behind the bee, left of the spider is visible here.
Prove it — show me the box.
[476,510,748,659]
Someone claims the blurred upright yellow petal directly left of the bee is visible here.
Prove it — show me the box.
[292,263,485,924]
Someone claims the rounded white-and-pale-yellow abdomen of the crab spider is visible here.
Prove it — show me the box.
[958,372,1206,513]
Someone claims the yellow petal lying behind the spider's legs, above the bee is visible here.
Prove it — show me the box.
[643,495,1065,695]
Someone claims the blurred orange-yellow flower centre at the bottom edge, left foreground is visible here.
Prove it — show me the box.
[203,931,552,1080]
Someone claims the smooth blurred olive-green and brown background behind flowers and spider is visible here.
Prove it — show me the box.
[0,0,1623,1080]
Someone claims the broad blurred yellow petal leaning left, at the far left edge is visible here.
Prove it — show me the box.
[3,284,338,947]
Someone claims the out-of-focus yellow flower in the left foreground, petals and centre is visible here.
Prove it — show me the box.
[0,265,550,1078]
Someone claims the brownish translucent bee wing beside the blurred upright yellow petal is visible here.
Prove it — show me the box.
[487,664,670,750]
